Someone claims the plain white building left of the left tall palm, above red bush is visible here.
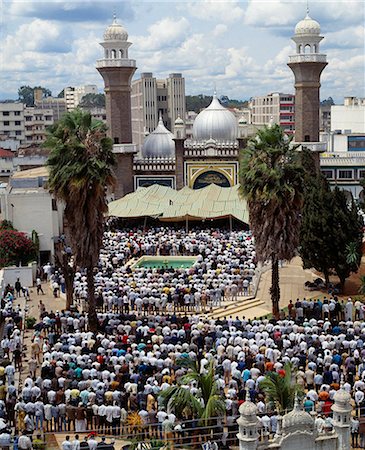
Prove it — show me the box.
[0,167,64,263]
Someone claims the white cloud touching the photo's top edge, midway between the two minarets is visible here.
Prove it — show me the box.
[181,0,244,22]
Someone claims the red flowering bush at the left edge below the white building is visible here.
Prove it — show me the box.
[0,229,37,267]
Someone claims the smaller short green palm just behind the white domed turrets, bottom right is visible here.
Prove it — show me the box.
[259,363,302,413]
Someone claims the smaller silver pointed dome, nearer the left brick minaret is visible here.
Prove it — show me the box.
[142,117,175,158]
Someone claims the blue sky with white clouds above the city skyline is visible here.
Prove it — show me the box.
[0,0,365,103]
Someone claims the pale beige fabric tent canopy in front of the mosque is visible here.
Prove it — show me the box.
[109,184,249,223]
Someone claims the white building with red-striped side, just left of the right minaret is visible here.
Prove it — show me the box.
[250,92,295,134]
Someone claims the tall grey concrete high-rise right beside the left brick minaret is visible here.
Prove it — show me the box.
[132,72,186,148]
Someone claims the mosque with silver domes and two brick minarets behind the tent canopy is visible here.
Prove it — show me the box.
[96,7,327,199]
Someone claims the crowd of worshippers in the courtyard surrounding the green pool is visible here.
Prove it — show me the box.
[75,227,256,314]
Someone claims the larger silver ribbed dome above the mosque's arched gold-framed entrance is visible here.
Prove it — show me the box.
[193,93,237,141]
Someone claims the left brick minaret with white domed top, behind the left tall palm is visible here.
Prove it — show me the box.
[96,16,136,198]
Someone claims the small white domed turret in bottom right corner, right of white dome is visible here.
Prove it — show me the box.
[331,376,352,450]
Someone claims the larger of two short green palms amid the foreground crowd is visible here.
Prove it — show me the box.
[160,358,225,426]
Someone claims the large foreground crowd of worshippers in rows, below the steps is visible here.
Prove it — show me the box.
[0,298,365,441]
